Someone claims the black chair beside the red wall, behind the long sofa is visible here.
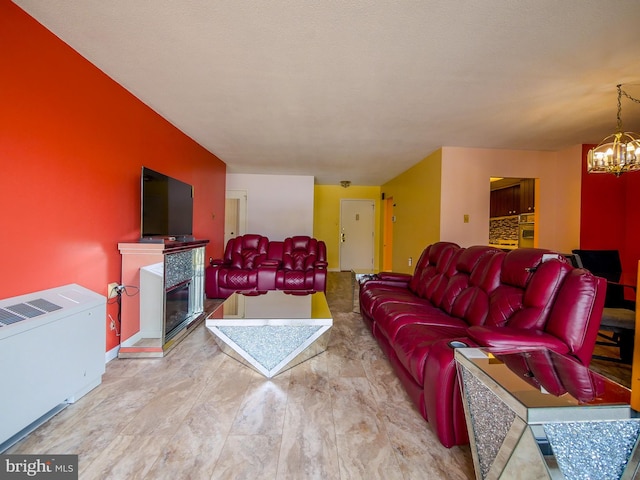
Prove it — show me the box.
[572,249,636,364]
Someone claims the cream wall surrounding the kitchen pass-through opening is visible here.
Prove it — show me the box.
[440,145,582,252]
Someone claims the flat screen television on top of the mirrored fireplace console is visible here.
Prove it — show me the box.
[140,167,193,239]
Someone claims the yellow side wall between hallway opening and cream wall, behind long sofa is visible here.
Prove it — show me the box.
[382,150,444,273]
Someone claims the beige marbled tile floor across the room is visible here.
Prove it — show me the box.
[7,273,624,480]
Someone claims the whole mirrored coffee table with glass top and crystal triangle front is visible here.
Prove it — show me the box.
[206,290,333,378]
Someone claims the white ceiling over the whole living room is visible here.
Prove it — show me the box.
[14,0,640,185]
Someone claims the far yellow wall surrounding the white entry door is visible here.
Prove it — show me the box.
[313,185,380,270]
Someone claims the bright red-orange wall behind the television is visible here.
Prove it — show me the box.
[0,0,226,351]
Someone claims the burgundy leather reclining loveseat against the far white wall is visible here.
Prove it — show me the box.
[205,234,327,298]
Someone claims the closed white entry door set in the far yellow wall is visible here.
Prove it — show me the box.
[340,199,375,271]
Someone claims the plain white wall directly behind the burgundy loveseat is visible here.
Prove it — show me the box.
[227,173,314,240]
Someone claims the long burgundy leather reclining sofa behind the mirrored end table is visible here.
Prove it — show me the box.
[360,242,606,447]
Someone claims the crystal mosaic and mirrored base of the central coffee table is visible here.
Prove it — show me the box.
[207,320,331,378]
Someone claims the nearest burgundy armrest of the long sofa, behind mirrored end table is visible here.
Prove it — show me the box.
[467,325,569,354]
